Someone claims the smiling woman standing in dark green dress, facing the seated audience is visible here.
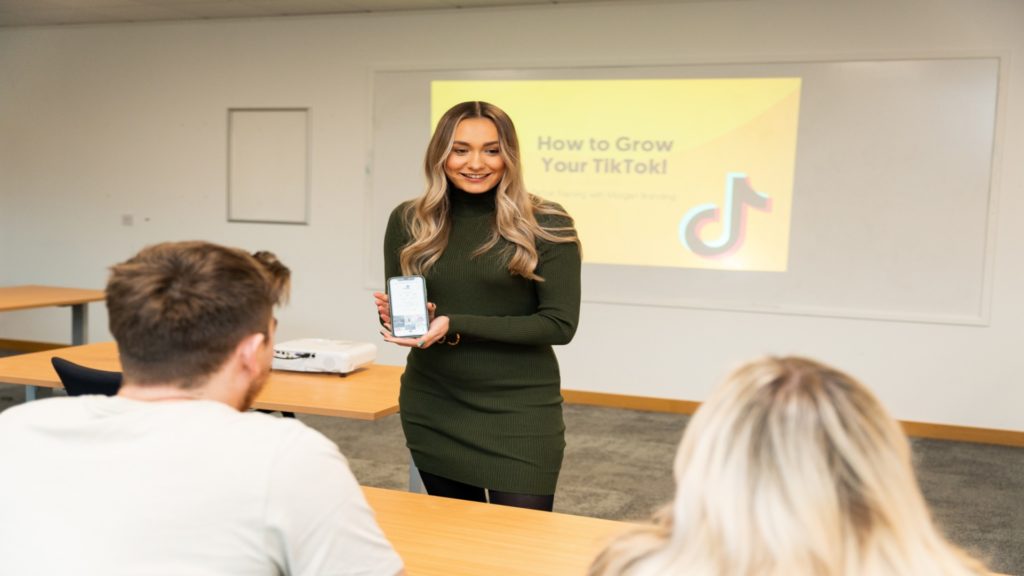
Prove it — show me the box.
[374,101,581,510]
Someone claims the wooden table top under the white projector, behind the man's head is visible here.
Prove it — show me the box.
[0,342,404,420]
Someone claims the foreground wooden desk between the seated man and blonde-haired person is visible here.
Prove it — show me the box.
[362,487,632,576]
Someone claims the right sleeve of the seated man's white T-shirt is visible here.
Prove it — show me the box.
[266,422,403,576]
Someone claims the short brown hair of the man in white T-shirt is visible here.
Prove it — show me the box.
[106,237,291,387]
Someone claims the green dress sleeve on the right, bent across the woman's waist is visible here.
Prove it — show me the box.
[449,212,581,345]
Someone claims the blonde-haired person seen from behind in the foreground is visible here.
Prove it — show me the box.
[590,358,989,576]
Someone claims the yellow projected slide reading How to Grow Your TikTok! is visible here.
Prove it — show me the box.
[431,78,801,272]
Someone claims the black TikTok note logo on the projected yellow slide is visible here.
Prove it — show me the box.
[679,172,771,258]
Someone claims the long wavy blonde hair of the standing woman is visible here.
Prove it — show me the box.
[399,101,580,282]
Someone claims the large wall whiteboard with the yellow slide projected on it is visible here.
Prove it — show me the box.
[367,57,1000,324]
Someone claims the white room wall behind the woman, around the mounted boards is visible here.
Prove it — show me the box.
[0,0,1024,429]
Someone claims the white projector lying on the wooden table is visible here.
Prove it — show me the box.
[271,338,377,374]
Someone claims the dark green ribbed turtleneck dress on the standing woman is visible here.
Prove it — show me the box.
[384,186,580,495]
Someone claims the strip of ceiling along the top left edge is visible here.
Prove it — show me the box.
[0,0,630,28]
